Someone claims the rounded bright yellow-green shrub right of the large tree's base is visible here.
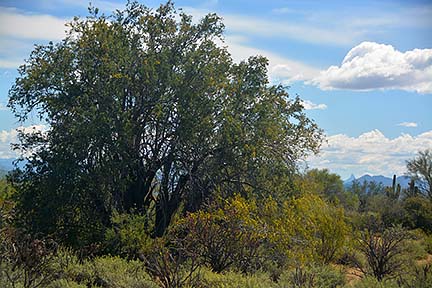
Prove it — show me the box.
[263,194,349,266]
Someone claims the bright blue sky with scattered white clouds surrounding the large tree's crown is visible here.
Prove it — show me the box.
[0,0,432,178]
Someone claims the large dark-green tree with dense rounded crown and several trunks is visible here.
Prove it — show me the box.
[9,2,322,243]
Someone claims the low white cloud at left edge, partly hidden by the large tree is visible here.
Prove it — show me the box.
[0,124,47,159]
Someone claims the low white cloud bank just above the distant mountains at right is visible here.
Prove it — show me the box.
[308,130,432,177]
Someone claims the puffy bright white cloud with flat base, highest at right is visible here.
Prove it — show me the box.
[310,42,432,93]
